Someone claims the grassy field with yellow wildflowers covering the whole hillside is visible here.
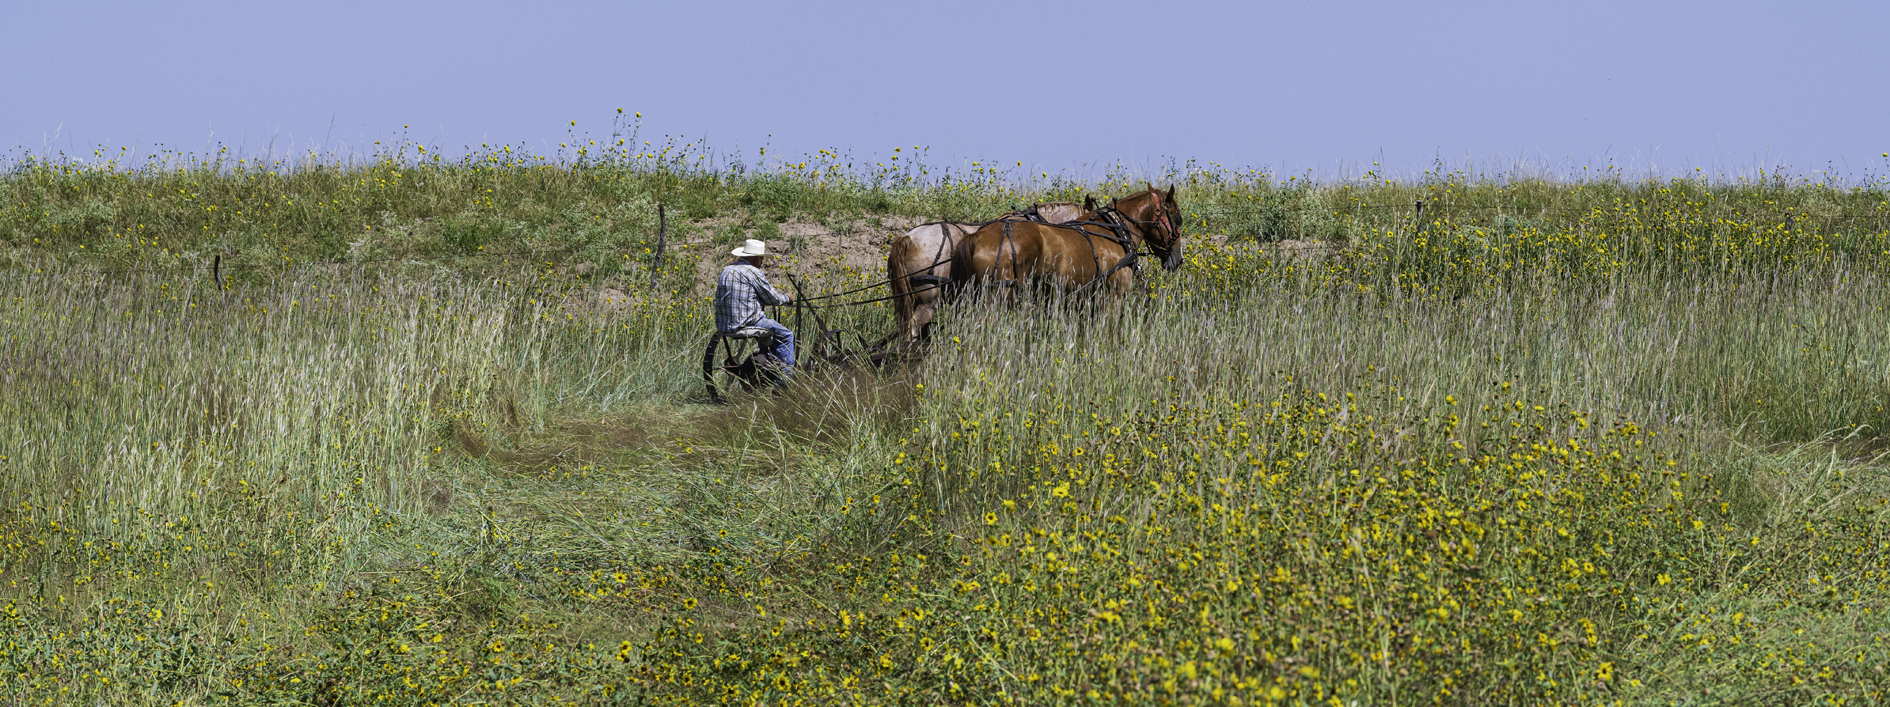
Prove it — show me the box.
[0,123,1890,705]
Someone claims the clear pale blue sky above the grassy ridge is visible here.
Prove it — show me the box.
[0,0,1890,176]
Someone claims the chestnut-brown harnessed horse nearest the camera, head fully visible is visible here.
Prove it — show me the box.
[951,187,1181,293]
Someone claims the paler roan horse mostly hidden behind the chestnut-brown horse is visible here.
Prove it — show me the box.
[886,202,1085,344]
